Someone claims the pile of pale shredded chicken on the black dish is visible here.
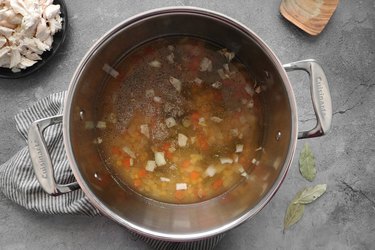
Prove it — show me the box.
[0,0,62,72]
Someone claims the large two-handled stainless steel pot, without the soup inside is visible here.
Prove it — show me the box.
[29,7,332,241]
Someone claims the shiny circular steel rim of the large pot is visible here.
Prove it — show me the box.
[63,6,298,241]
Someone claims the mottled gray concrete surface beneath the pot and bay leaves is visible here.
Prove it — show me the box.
[0,0,375,250]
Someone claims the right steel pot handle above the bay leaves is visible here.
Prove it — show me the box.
[283,59,332,139]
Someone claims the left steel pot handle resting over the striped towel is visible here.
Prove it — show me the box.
[28,115,79,196]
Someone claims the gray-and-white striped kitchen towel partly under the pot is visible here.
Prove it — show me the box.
[0,92,224,250]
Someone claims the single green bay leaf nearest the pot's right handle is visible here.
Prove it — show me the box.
[299,143,316,181]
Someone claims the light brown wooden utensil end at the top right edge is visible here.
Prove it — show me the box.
[280,0,339,36]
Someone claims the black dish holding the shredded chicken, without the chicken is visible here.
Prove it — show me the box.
[0,0,68,79]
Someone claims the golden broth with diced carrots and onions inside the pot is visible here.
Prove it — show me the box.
[95,37,262,203]
